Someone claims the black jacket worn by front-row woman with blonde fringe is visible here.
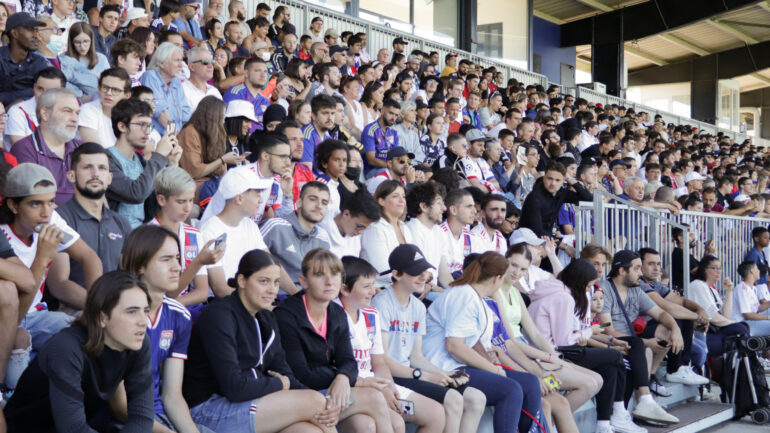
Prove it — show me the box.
[275,291,358,390]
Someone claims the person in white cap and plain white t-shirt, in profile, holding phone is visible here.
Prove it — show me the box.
[201,166,273,297]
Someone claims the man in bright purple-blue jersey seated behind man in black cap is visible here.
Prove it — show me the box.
[361,99,401,177]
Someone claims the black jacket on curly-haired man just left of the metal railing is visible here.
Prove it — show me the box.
[519,178,593,237]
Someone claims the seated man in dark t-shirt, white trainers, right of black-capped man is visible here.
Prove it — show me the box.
[639,248,708,387]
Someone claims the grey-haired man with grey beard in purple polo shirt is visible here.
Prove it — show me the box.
[11,88,80,204]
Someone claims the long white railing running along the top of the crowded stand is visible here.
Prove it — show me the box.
[250,0,770,146]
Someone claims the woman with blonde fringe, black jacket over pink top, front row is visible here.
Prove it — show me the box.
[275,248,396,433]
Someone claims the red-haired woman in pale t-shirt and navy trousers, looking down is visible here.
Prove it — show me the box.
[423,251,541,433]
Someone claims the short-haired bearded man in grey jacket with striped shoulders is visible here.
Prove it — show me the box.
[260,181,330,295]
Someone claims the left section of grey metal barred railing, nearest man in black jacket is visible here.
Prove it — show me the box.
[575,189,690,296]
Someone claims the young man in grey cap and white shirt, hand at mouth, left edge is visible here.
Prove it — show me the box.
[0,163,102,382]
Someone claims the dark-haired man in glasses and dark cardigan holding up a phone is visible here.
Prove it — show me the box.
[106,97,182,228]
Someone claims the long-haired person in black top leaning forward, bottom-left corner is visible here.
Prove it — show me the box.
[5,271,154,433]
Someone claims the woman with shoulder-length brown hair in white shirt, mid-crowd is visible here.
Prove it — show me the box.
[361,180,413,287]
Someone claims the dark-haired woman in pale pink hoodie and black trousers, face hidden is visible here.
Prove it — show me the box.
[529,259,646,433]
